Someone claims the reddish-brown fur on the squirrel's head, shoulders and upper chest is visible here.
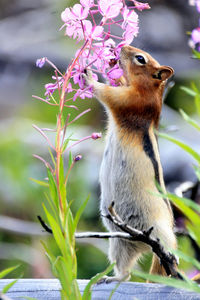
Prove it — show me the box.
[100,46,173,131]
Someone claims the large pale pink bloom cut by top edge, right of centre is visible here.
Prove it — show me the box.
[98,0,123,21]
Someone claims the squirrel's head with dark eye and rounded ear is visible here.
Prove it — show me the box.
[119,46,174,88]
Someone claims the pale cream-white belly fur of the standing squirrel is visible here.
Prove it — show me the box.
[100,117,173,246]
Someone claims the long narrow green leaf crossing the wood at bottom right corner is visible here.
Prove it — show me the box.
[134,270,200,293]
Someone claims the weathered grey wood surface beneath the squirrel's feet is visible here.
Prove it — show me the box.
[0,279,200,300]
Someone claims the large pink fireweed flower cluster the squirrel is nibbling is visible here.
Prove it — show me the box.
[37,0,150,100]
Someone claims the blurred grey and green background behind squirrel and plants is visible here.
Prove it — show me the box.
[0,0,200,278]
